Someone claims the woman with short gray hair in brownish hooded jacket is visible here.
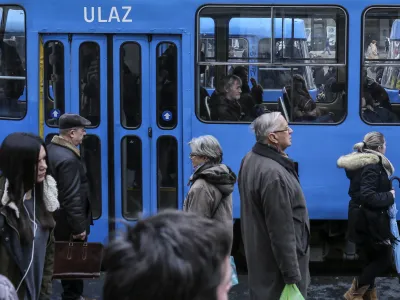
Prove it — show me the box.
[183,135,236,226]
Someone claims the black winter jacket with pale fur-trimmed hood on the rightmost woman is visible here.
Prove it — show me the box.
[338,152,395,244]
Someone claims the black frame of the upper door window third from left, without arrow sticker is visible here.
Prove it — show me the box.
[119,41,143,129]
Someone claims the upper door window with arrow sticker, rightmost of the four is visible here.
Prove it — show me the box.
[156,42,178,129]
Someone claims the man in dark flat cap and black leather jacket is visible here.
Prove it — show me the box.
[47,114,93,300]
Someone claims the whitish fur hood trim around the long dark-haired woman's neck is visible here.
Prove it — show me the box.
[1,175,60,218]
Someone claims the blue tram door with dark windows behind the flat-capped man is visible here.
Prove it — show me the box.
[41,35,108,242]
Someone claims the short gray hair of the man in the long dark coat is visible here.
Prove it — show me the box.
[250,111,282,143]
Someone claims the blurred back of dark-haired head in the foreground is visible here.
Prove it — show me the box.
[103,210,232,300]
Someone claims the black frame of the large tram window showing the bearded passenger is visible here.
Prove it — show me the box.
[195,4,349,126]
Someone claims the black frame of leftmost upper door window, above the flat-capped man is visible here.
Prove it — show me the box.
[43,40,65,128]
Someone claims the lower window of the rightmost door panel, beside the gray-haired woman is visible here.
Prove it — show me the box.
[157,136,178,210]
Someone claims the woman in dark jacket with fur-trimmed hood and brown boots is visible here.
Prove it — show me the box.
[337,132,396,300]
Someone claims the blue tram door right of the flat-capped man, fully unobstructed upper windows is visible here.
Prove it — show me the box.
[113,36,183,221]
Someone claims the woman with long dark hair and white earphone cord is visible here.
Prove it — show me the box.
[0,132,59,300]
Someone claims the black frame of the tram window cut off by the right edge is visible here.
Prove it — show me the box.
[359,5,400,126]
